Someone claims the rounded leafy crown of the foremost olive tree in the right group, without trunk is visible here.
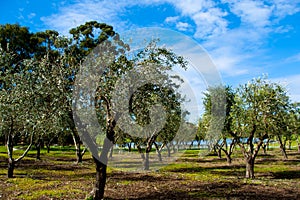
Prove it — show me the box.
[231,76,290,140]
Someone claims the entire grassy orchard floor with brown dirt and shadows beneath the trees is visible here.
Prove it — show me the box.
[0,147,300,199]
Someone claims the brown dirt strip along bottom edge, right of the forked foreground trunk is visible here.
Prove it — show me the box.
[105,173,300,199]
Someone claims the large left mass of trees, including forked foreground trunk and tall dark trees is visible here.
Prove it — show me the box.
[0,21,190,199]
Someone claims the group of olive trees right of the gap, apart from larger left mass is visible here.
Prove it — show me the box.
[198,77,300,178]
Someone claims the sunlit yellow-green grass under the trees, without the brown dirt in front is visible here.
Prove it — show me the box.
[0,146,300,199]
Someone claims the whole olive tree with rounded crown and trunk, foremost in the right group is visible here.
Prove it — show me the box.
[230,78,289,178]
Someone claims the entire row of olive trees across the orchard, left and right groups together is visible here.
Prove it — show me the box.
[0,21,299,199]
